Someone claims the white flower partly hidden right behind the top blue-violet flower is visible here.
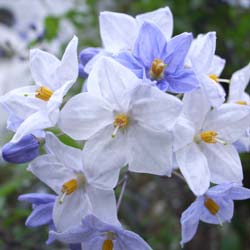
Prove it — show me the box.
[185,32,225,107]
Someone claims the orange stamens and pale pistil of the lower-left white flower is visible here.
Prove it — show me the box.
[59,174,87,204]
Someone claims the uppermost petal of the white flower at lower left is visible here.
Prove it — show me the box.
[45,132,83,171]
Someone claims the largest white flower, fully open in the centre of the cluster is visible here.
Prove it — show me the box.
[58,57,182,175]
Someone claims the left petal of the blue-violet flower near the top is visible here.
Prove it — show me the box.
[113,52,144,79]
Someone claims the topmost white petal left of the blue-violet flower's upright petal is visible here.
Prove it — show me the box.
[99,11,137,53]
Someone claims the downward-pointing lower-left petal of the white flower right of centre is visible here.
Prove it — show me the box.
[176,143,210,196]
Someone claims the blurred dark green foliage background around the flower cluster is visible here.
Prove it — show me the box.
[0,0,250,250]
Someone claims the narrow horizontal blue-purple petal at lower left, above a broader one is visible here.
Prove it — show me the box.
[18,193,56,205]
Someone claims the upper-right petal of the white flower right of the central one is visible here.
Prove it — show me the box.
[203,103,250,143]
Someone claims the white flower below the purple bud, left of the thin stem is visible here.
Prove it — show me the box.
[28,133,119,232]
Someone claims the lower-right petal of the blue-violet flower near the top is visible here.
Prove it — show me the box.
[164,66,199,93]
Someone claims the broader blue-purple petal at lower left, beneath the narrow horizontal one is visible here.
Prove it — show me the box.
[25,203,54,227]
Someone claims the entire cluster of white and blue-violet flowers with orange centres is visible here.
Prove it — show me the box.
[0,7,250,250]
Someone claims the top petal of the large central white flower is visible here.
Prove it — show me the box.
[88,57,141,110]
